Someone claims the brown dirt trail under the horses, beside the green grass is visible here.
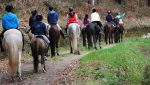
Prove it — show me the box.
[0,46,111,85]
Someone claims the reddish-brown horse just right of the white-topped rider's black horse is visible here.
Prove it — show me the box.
[104,22,114,44]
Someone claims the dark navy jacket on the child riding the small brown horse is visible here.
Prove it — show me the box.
[31,21,46,35]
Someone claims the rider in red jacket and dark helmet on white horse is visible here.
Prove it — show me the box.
[65,7,79,33]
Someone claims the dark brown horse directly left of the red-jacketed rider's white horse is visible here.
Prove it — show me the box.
[49,25,60,57]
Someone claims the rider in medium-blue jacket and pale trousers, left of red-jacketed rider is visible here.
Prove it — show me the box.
[47,6,65,39]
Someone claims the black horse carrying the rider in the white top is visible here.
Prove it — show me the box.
[85,23,102,49]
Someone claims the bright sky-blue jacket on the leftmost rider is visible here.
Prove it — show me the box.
[2,12,19,30]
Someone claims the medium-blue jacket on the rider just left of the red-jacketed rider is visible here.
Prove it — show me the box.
[47,10,58,25]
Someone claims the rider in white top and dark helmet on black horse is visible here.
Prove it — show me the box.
[91,8,102,27]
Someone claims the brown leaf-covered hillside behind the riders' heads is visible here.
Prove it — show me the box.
[0,0,150,29]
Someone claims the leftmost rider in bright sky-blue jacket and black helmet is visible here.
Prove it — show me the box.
[0,4,24,51]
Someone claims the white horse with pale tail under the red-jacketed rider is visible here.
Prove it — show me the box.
[67,23,80,55]
